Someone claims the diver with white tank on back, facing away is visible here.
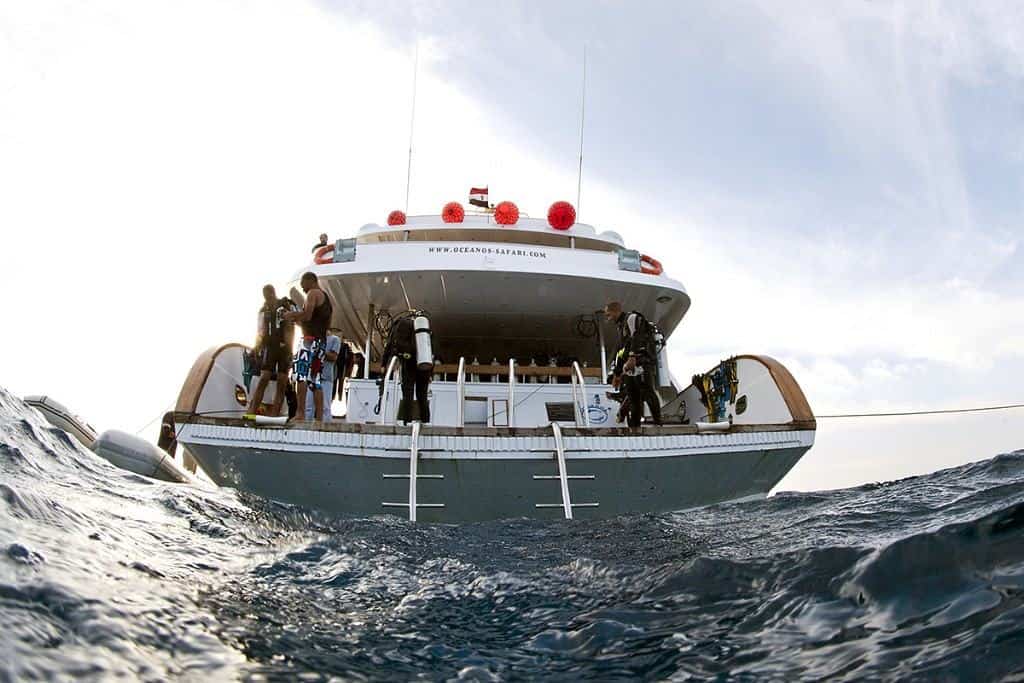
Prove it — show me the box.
[381,310,434,425]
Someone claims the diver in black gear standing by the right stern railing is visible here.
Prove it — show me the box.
[604,301,662,429]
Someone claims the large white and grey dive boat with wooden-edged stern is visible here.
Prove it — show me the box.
[175,203,816,522]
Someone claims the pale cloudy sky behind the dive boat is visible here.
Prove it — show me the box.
[0,0,1024,490]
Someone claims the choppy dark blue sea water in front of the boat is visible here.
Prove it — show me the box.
[0,389,1024,681]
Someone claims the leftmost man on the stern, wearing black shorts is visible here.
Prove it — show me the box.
[249,285,295,416]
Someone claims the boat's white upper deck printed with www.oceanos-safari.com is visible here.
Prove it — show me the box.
[295,215,690,374]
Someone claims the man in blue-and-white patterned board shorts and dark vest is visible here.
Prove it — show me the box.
[285,271,334,422]
